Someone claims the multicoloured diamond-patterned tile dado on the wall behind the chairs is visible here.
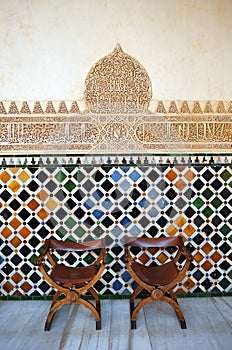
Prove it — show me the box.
[0,159,232,296]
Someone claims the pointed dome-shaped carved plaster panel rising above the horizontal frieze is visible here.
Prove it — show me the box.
[84,45,152,113]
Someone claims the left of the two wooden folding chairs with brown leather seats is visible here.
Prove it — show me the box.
[36,238,106,331]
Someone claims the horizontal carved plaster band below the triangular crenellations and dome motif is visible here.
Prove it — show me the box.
[0,114,232,153]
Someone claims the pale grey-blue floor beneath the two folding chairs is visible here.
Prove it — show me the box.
[0,297,232,350]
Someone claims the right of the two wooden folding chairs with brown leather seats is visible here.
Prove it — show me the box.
[124,236,192,329]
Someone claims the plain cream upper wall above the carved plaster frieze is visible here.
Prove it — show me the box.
[0,0,232,100]
